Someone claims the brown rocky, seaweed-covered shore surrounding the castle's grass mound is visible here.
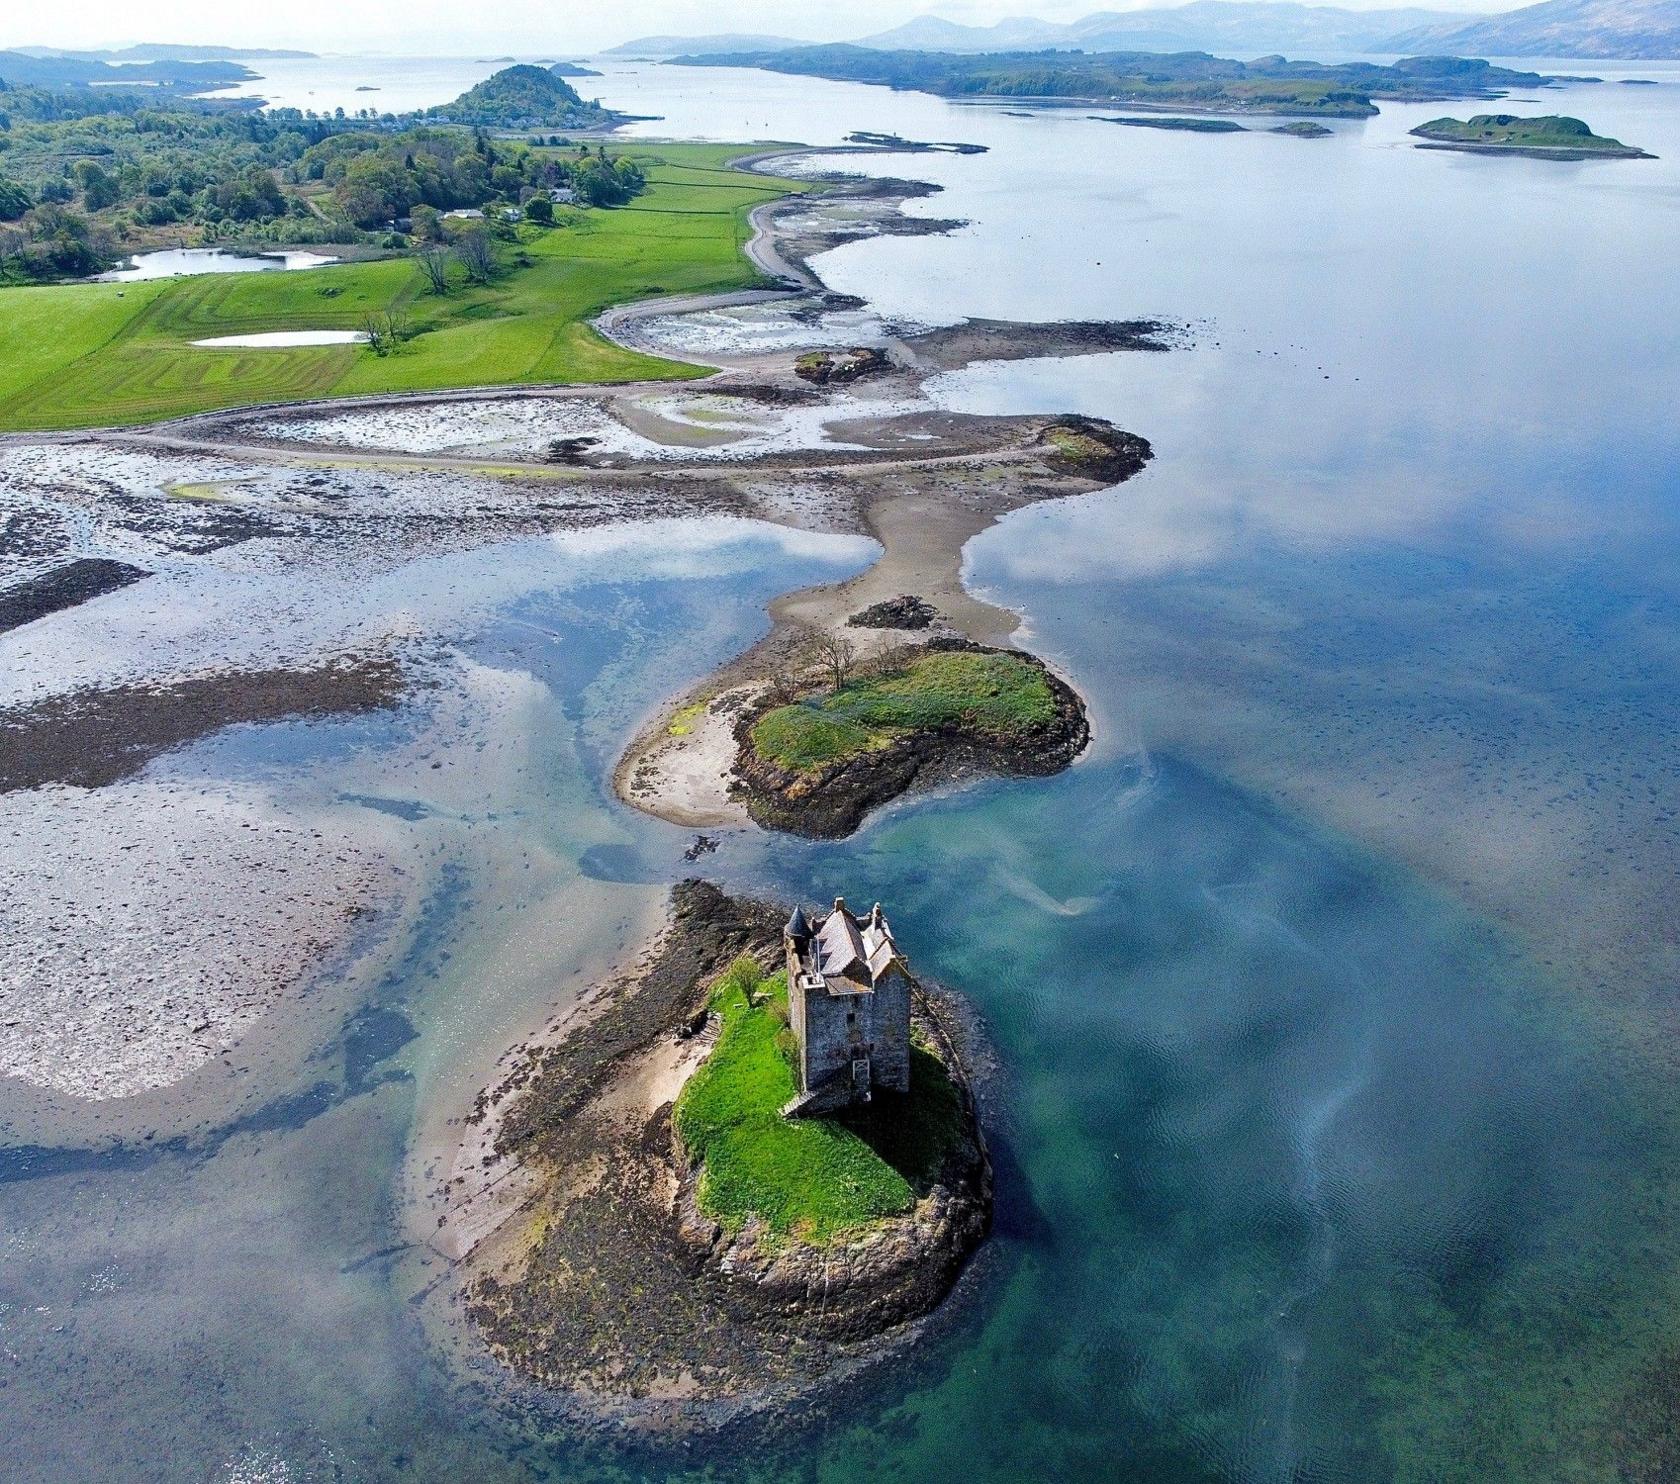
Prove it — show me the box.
[453,881,993,1432]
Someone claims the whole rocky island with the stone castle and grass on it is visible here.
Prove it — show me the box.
[464,881,991,1427]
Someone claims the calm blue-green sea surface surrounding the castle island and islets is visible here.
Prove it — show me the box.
[0,64,1680,1484]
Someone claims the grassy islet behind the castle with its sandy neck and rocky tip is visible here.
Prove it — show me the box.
[613,411,1151,839]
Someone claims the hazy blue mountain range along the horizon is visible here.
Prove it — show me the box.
[608,0,1680,59]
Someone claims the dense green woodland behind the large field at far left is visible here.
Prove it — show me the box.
[0,74,647,277]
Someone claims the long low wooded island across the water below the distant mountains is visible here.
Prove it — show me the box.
[674,45,1552,118]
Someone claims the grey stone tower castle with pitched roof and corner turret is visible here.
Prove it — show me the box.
[781,897,911,1118]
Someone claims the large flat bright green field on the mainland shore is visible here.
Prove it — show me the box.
[0,143,803,430]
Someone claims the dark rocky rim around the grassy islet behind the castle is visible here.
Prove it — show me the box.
[731,639,1090,840]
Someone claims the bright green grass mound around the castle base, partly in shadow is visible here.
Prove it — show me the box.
[674,960,963,1242]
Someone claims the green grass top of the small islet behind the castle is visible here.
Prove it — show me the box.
[753,650,1055,768]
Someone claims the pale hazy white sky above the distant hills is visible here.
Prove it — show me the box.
[0,0,1520,55]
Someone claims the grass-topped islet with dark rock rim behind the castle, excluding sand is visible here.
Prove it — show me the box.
[734,640,1090,839]
